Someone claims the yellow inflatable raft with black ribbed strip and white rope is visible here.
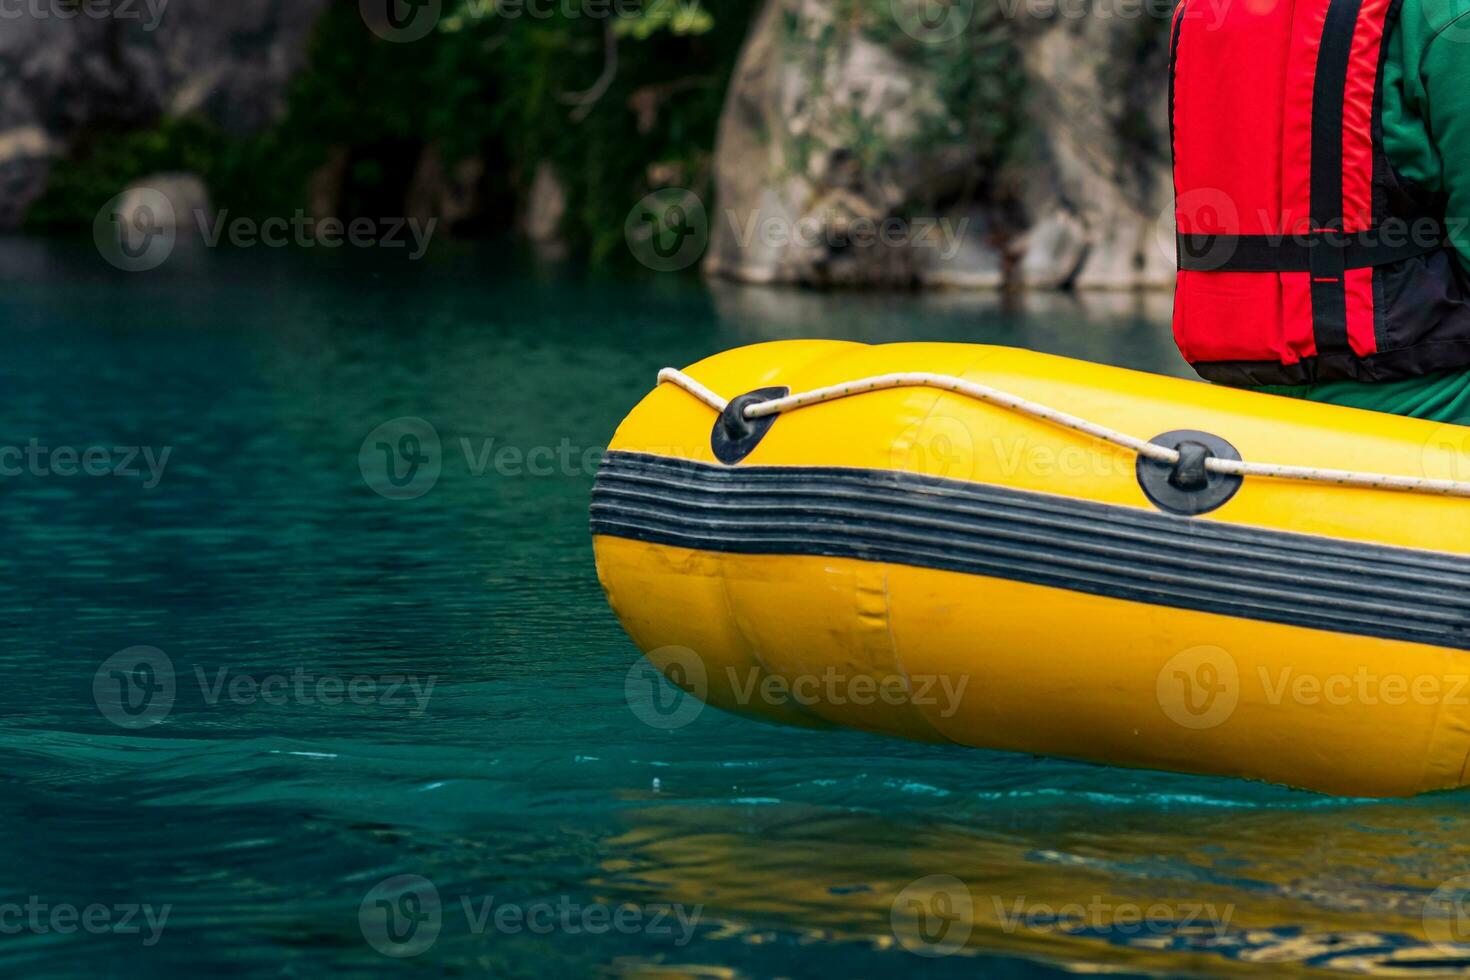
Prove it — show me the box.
[592,341,1470,795]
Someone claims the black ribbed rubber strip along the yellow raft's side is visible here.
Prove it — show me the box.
[592,453,1470,649]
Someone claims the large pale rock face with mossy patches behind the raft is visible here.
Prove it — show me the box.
[706,0,1173,288]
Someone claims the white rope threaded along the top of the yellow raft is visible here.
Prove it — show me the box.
[659,367,1470,497]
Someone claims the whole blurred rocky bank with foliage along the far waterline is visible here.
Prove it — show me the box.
[0,0,1173,288]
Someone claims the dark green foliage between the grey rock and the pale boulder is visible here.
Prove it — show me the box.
[28,0,759,259]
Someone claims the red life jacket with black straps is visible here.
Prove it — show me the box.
[1169,0,1470,385]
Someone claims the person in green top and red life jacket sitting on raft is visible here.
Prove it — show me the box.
[1170,0,1470,423]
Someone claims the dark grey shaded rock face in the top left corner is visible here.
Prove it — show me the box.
[0,0,328,228]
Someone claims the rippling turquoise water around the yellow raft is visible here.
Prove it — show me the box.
[0,241,1470,977]
